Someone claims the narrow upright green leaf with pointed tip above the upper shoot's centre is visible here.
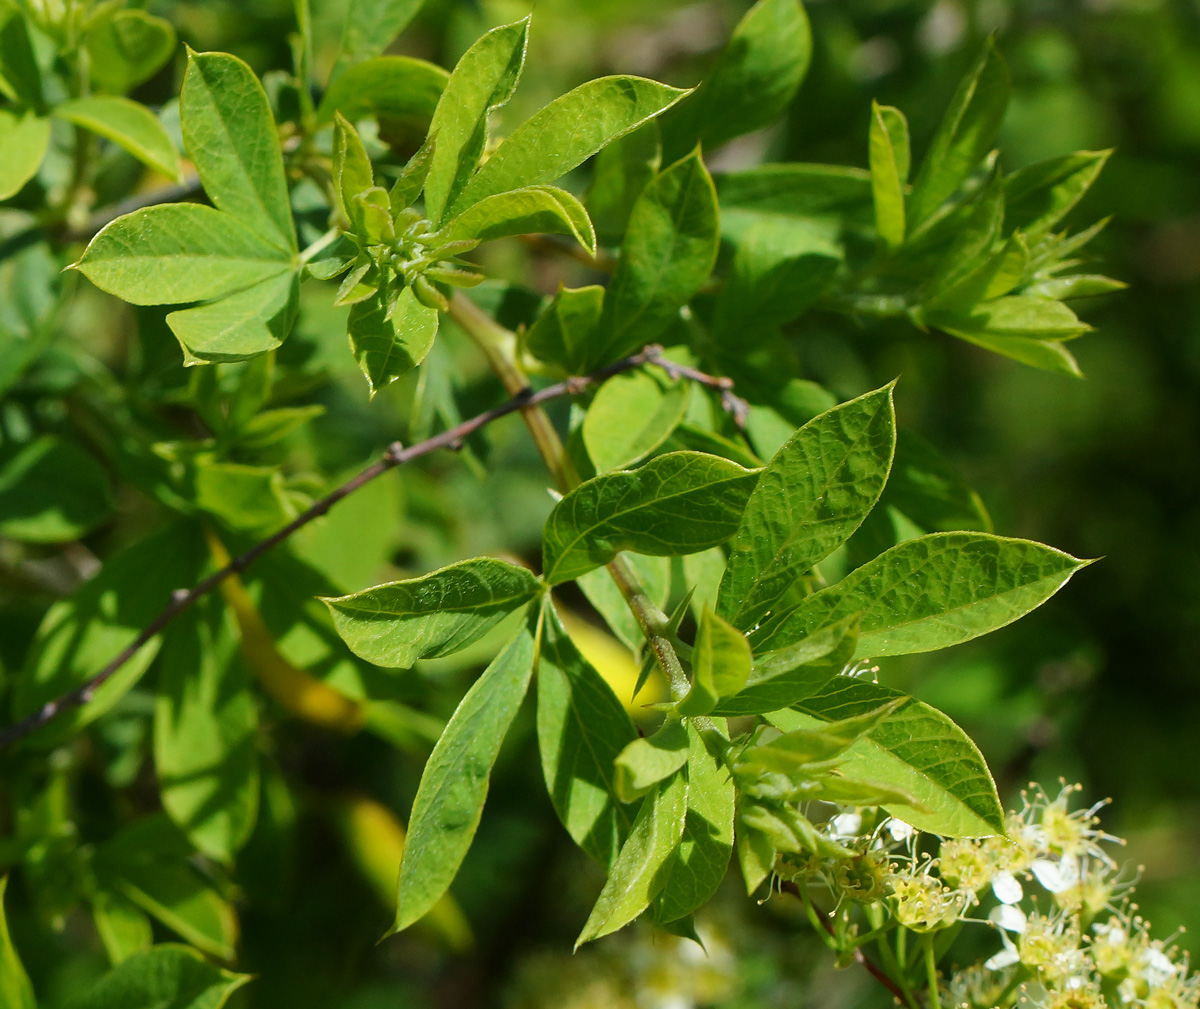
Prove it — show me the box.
[425,17,529,226]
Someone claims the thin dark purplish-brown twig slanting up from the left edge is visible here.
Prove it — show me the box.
[0,344,700,750]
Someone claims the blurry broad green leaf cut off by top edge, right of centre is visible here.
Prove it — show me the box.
[662,0,812,161]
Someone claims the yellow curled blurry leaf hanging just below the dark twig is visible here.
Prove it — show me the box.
[204,529,364,732]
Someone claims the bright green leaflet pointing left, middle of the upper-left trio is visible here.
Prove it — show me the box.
[74,203,292,305]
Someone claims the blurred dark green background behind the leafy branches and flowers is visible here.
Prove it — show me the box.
[2,0,1200,1009]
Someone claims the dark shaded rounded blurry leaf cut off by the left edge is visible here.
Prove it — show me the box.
[0,434,113,543]
